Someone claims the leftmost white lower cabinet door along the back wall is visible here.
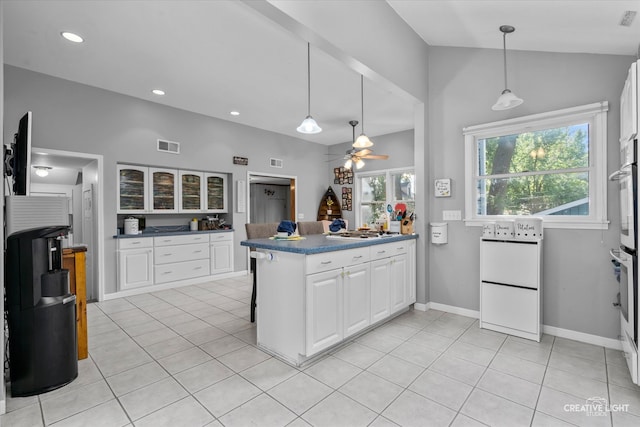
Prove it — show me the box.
[118,237,153,291]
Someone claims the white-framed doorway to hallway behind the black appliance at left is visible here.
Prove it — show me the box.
[31,147,104,301]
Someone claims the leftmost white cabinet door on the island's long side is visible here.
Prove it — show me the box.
[306,269,343,356]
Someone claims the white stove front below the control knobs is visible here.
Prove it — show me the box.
[480,239,542,341]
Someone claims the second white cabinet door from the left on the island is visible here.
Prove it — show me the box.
[342,263,371,338]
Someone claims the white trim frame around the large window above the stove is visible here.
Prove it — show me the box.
[463,101,609,230]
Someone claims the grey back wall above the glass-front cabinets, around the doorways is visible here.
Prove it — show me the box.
[4,65,327,293]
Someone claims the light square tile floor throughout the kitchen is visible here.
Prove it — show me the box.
[0,277,640,427]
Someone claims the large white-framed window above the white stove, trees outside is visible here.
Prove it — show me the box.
[464,102,608,228]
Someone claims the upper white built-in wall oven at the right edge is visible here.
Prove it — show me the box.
[609,140,638,250]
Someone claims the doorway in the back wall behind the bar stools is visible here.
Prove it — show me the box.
[247,172,298,224]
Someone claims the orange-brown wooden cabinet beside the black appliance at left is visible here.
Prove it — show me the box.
[62,247,89,360]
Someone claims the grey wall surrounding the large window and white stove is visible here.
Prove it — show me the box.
[428,47,634,339]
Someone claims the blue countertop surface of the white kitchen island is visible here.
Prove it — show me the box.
[240,234,418,255]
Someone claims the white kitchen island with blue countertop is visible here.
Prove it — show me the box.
[240,234,418,366]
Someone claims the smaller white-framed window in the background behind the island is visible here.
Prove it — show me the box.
[355,169,416,226]
